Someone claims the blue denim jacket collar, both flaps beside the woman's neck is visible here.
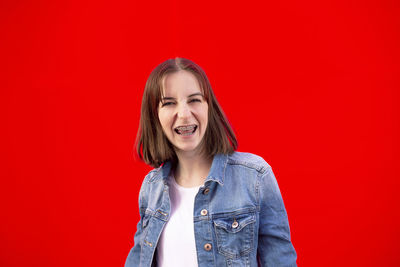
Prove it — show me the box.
[150,154,229,185]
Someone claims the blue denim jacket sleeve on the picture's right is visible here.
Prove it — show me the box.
[257,166,297,267]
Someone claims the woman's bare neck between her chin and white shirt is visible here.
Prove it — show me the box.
[175,151,213,187]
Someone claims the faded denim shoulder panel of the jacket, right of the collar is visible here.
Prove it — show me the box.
[227,151,271,173]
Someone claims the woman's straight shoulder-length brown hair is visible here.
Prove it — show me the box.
[136,58,237,167]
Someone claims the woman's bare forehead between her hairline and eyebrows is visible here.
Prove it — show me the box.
[161,70,202,96]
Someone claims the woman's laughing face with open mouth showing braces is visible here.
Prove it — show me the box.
[158,70,208,156]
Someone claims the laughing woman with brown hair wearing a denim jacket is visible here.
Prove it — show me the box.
[125,58,296,267]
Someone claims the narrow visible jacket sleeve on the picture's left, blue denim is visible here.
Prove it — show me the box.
[125,182,145,267]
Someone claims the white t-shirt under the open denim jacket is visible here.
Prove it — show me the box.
[157,174,200,267]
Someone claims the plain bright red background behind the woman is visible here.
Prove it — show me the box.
[0,0,400,267]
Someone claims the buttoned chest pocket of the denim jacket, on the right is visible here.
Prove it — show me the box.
[213,213,256,259]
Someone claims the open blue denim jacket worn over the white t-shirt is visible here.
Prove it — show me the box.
[125,152,297,267]
